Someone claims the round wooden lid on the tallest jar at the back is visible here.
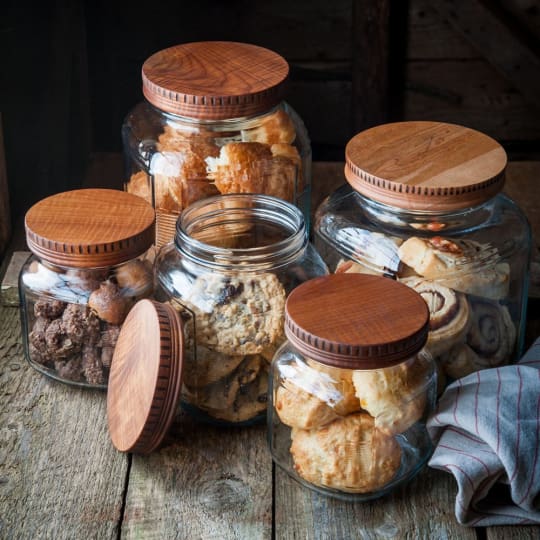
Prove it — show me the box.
[142,41,289,120]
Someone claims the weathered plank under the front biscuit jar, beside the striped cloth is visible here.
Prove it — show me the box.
[274,468,476,540]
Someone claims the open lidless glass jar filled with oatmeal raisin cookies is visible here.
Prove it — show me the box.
[155,194,328,424]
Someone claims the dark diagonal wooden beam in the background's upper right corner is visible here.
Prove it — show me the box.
[433,0,540,108]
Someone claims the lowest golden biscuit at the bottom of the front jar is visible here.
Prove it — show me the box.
[290,413,401,493]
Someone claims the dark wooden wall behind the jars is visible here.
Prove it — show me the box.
[0,0,540,253]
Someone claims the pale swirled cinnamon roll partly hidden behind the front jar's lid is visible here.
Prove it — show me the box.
[401,277,471,356]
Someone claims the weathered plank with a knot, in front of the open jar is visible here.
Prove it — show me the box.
[122,422,272,540]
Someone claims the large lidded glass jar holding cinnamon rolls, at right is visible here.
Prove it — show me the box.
[314,122,531,387]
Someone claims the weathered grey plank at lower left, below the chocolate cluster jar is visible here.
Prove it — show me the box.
[0,306,128,540]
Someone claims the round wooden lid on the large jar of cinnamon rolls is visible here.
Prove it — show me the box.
[345,122,507,211]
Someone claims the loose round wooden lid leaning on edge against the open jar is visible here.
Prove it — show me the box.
[107,299,184,454]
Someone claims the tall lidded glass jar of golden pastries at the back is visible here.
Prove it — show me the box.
[122,41,311,246]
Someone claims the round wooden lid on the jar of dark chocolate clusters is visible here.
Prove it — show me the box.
[25,189,155,268]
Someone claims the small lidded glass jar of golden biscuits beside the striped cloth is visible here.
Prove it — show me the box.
[268,274,437,501]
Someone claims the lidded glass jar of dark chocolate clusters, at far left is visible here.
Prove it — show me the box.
[19,189,155,389]
